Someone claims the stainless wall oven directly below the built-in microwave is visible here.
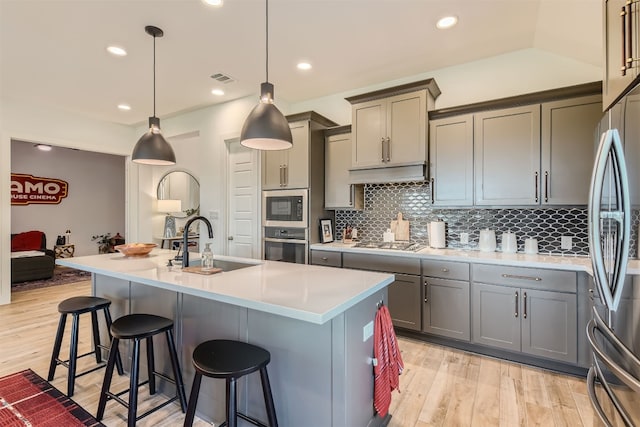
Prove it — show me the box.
[264,227,309,264]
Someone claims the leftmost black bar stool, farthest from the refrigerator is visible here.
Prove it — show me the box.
[47,296,123,397]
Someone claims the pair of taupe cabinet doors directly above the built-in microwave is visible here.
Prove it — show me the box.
[262,121,309,190]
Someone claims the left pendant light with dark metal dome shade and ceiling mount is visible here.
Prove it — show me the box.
[131,25,176,166]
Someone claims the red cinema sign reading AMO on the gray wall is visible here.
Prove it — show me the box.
[11,173,69,205]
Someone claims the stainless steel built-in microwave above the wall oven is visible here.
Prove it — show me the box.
[262,189,309,228]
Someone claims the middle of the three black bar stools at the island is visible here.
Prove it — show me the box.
[96,314,187,427]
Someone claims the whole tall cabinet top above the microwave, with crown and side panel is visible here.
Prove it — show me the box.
[262,111,336,193]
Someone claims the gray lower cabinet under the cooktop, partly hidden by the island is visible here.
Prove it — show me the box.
[342,252,422,331]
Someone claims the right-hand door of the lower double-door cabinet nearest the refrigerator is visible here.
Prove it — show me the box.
[521,288,584,363]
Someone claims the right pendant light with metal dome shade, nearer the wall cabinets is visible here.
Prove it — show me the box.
[240,0,293,150]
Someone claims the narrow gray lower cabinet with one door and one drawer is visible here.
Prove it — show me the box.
[422,260,471,341]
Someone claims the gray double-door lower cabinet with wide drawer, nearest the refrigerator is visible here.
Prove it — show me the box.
[472,265,578,364]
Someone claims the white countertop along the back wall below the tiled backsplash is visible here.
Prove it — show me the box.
[311,242,640,275]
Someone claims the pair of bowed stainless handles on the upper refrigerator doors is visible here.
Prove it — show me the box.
[589,129,631,311]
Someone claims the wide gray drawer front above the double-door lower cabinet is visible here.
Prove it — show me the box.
[472,264,577,293]
